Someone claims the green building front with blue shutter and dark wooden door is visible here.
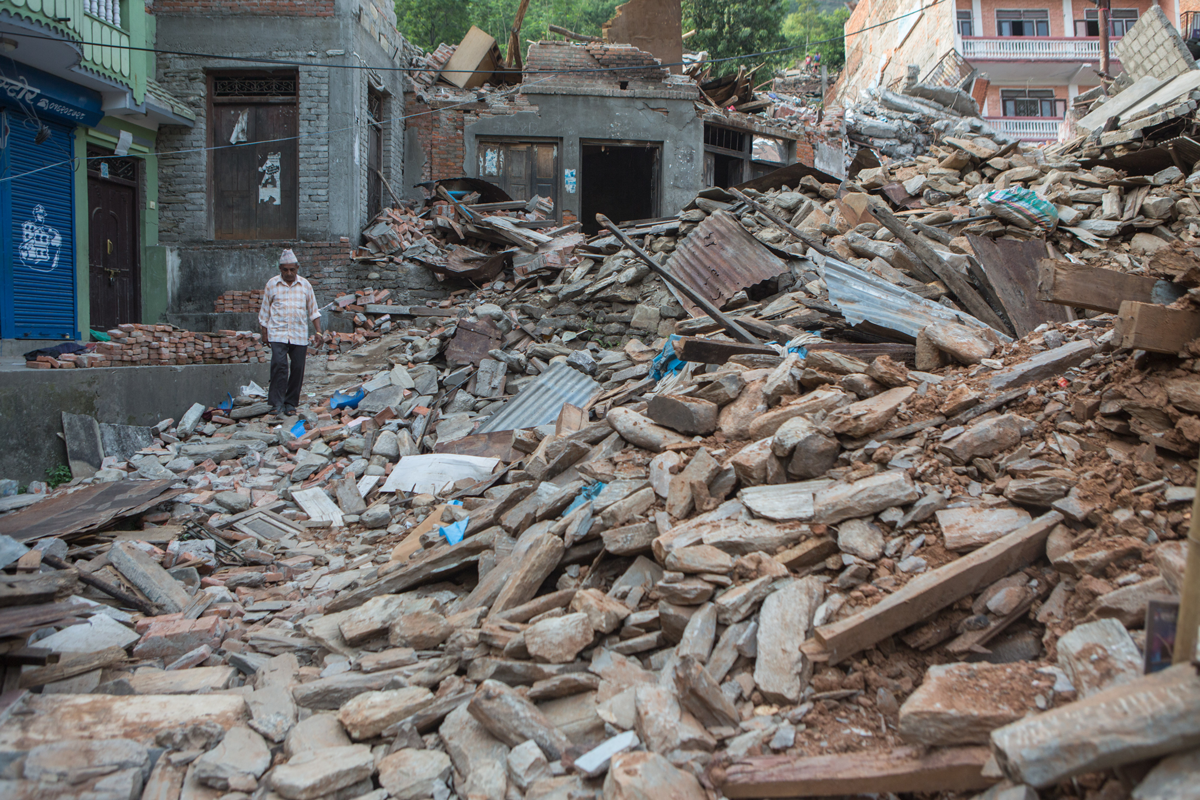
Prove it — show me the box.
[0,0,193,355]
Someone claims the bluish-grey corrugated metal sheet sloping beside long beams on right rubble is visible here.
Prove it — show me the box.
[821,258,1012,342]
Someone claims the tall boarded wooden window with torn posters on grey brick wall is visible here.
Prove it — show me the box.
[208,71,300,240]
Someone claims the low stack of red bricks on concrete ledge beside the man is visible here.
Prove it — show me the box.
[25,325,268,369]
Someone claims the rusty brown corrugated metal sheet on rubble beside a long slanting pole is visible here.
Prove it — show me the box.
[667,211,787,317]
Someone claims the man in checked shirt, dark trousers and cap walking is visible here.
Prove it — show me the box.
[258,249,320,416]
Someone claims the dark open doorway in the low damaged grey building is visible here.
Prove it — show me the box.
[580,140,662,235]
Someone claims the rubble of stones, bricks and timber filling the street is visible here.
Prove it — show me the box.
[11,6,1200,800]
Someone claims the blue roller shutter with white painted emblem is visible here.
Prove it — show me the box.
[5,112,79,339]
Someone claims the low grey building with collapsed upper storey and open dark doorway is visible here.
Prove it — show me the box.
[406,42,835,233]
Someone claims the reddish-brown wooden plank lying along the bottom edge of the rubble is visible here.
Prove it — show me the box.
[714,747,995,800]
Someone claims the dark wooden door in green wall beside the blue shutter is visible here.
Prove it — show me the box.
[88,174,142,331]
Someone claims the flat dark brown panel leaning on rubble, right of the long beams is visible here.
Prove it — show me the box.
[967,234,1070,337]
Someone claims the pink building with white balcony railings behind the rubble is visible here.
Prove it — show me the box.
[832,0,1185,142]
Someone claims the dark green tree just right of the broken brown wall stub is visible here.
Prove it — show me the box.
[683,0,788,74]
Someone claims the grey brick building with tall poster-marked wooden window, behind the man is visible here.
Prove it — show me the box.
[155,0,437,330]
